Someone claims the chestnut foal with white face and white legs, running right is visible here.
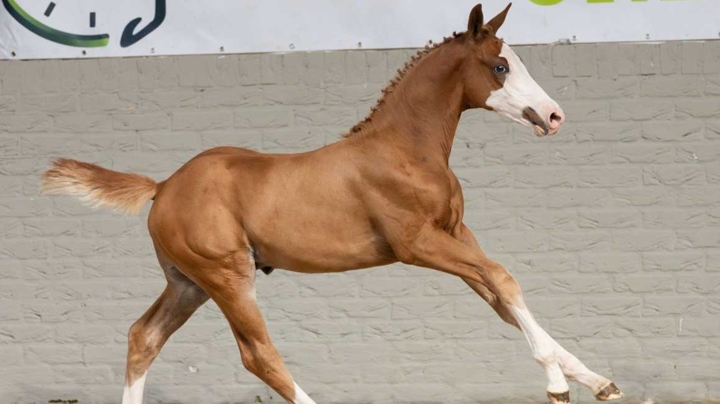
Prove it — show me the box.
[43,5,622,404]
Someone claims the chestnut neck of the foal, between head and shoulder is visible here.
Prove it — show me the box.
[360,41,464,164]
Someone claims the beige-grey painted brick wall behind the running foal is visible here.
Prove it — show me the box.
[0,41,720,404]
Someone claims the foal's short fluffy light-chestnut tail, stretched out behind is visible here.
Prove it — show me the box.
[41,159,158,215]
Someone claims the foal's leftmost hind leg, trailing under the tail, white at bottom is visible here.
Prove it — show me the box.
[122,262,209,404]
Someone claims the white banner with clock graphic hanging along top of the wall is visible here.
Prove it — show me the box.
[0,0,720,59]
